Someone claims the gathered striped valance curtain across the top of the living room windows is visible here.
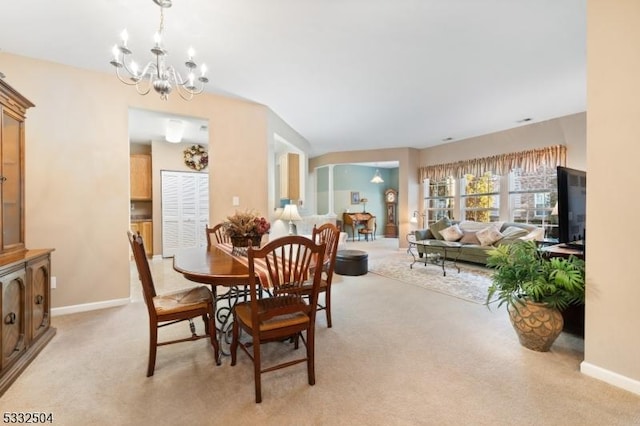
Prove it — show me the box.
[418,145,567,182]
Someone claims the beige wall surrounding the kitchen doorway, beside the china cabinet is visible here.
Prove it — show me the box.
[0,53,272,308]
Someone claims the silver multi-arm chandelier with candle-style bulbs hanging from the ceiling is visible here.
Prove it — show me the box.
[110,0,209,100]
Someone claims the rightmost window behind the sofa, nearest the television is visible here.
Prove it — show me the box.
[509,166,558,235]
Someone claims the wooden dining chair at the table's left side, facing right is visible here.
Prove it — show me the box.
[127,231,219,377]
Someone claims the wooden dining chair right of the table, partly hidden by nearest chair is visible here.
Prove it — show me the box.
[303,223,340,328]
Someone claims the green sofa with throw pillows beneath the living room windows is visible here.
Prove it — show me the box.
[414,217,544,265]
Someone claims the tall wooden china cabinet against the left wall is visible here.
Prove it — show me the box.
[0,79,55,395]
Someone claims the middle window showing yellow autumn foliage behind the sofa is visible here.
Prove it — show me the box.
[460,172,500,222]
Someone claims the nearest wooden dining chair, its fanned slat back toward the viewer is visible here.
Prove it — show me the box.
[231,235,325,403]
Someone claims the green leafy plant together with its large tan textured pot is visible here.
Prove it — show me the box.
[486,241,585,352]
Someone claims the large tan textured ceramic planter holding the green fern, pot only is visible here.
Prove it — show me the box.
[507,301,564,352]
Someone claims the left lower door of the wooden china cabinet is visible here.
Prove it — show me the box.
[0,269,26,369]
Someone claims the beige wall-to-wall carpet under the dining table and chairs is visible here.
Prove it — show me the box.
[0,235,640,426]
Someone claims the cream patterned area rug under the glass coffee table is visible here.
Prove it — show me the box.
[369,252,491,304]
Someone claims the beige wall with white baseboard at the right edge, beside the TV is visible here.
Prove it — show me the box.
[582,0,640,394]
